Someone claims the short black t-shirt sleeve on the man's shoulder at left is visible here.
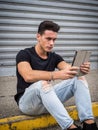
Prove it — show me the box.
[16,50,30,65]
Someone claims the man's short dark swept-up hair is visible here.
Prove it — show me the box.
[38,21,60,35]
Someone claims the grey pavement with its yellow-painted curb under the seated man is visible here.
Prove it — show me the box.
[0,70,98,130]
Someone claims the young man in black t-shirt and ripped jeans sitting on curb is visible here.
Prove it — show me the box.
[15,21,98,130]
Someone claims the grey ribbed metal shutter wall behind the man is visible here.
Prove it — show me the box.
[0,0,98,76]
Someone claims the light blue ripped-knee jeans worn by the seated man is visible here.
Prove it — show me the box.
[19,77,94,130]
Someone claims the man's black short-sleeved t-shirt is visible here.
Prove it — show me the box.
[15,47,64,103]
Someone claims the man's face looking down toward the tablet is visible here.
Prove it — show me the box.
[37,30,57,52]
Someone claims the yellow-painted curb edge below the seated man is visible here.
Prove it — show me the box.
[0,102,98,130]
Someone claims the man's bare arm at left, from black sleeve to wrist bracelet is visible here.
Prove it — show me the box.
[17,61,51,82]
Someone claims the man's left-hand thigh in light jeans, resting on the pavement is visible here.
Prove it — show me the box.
[19,81,47,115]
